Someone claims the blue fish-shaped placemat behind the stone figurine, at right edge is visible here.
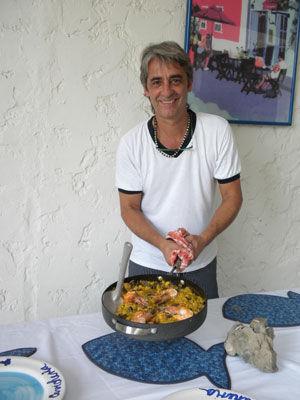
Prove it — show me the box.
[223,291,300,327]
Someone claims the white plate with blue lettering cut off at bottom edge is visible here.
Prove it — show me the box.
[162,388,254,400]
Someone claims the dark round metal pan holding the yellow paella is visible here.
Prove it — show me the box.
[102,274,207,341]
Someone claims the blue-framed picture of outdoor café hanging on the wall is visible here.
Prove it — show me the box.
[185,0,300,125]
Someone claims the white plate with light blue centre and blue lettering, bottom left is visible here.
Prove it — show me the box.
[0,356,66,400]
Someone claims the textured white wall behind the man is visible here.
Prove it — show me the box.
[0,0,300,324]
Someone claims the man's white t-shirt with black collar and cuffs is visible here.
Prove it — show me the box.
[116,113,241,272]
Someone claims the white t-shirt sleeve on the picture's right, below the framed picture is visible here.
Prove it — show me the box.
[214,121,241,180]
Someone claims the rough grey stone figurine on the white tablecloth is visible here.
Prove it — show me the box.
[224,318,278,372]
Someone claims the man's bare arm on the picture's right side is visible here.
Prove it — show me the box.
[186,179,243,260]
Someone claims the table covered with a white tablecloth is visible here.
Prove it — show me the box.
[0,288,300,400]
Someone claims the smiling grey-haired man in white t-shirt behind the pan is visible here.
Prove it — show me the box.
[116,42,242,298]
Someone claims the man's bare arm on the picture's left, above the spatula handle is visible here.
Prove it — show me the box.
[119,192,180,265]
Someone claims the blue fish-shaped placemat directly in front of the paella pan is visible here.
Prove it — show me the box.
[82,332,231,389]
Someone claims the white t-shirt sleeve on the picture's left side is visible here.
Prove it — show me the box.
[115,134,143,192]
